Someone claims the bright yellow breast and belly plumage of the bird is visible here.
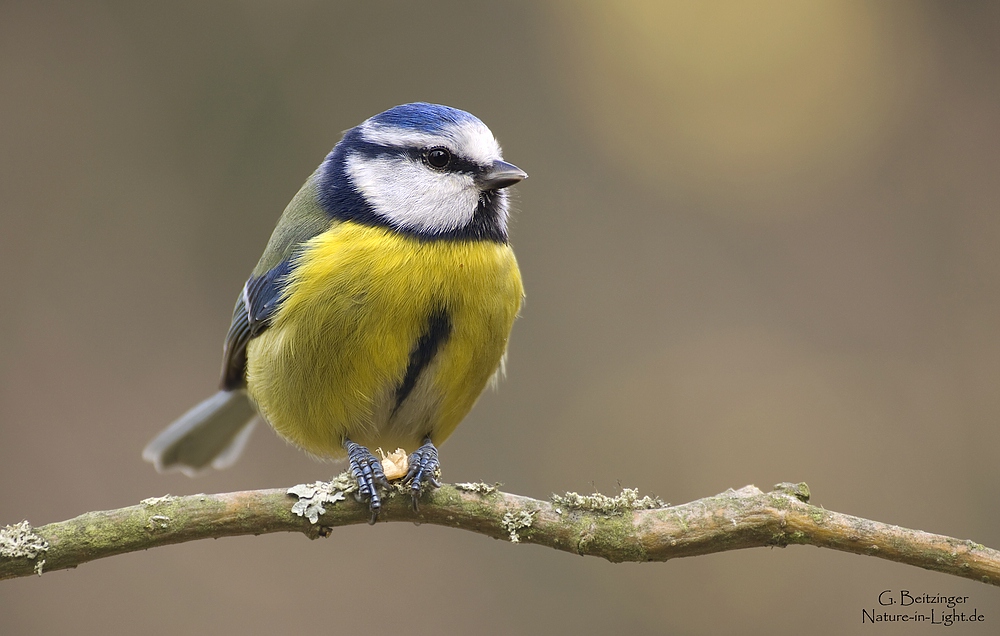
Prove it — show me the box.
[247,222,524,457]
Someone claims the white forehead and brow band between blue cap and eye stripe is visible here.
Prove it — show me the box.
[358,120,503,165]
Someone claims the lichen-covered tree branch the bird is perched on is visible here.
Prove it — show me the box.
[0,480,1000,585]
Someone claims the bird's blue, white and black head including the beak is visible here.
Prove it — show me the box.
[318,102,528,242]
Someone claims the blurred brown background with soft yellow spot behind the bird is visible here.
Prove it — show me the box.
[0,0,1000,636]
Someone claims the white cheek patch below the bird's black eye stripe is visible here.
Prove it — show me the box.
[345,152,479,234]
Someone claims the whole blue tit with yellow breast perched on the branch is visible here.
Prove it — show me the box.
[143,103,527,523]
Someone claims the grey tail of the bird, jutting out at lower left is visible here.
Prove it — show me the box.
[142,391,257,477]
